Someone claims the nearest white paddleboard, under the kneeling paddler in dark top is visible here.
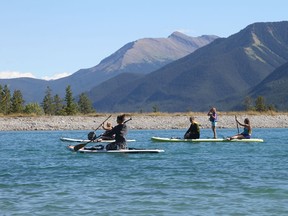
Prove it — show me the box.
[67,145,164,154]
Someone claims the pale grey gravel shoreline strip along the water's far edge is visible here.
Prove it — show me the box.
[0,114,288,131]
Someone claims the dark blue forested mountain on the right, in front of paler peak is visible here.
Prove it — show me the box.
[90,21,288,112]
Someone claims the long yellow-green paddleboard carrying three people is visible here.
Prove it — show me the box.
[151,137,264,142]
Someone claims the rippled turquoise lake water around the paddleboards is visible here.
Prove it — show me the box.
[0,129,288,215]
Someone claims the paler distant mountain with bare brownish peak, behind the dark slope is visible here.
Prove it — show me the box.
[0,32,218,102]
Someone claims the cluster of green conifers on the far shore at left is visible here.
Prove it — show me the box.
[0,85,95,115]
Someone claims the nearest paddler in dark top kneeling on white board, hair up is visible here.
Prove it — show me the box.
[106,114,128,150]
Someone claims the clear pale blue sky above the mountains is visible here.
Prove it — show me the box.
[0,0,288,79]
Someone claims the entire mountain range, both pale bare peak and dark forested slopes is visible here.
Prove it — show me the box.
[0,21,288,112]
